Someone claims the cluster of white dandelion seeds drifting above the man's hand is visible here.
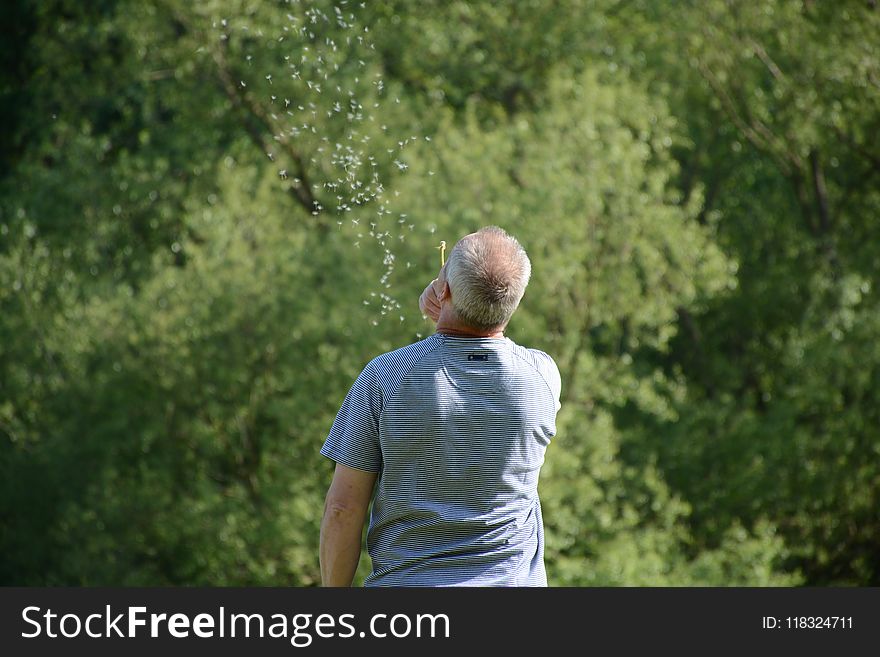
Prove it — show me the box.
[215,0,427,324]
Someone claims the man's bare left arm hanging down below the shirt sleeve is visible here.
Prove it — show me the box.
[320,463,376,586]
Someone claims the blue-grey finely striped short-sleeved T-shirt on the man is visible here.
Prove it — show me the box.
[321,334,561,586]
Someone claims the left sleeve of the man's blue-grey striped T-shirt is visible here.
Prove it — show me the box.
[321,363,382,472]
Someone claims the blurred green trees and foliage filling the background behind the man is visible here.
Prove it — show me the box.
[0,0,880,586]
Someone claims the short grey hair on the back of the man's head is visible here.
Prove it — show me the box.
[446,226,532,331]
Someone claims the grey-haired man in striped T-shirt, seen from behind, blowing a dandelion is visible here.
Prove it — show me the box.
[320,227,561,586]
